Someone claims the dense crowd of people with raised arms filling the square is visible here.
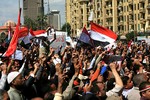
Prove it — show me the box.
[0,37,150,100]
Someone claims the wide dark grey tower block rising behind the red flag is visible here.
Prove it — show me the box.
[23,0,44,20]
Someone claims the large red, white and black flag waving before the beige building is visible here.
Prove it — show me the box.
[90,22,117,47]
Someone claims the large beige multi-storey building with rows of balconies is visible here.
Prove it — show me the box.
[66,0,150,36]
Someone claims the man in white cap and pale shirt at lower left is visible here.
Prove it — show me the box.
[7,71,25,100]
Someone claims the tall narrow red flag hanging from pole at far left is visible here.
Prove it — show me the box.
[3,8,21,57]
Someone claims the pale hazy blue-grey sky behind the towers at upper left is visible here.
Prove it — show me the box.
[0,0,65,26]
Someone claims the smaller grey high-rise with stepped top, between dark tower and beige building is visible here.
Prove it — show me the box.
[47,10,61,30]
